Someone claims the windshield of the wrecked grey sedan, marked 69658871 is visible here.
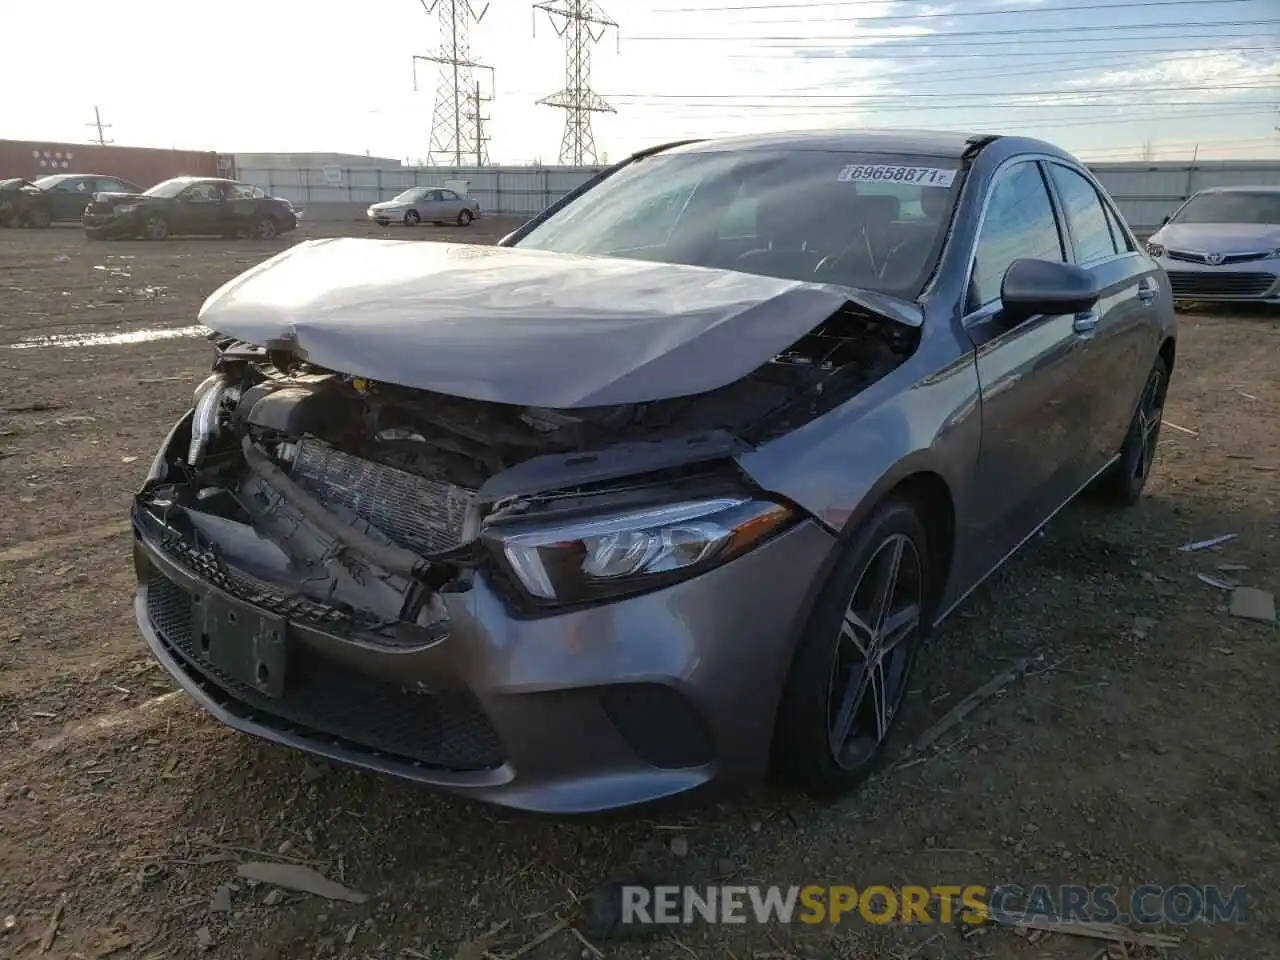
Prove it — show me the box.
[517,150,960,298]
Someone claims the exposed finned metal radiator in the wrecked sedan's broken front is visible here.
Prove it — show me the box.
[293,436,475,553]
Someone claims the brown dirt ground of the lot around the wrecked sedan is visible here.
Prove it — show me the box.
[0,223,1280,960]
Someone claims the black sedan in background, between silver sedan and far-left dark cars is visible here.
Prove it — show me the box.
[83,177,298,241]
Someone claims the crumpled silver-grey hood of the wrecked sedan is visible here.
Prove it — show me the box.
[200,238,919,408]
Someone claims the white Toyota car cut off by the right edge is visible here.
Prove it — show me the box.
[1147,187,1280,303]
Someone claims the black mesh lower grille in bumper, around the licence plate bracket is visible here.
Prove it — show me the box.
[147,573,502,771]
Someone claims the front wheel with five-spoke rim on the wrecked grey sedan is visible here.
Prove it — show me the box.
[773,499,934,799]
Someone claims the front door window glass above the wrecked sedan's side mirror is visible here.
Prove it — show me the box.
[970,160,1066,307]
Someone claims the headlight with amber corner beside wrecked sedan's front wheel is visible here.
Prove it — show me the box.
[484,498,794,603]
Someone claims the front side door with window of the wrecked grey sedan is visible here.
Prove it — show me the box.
[964,159,1091,568]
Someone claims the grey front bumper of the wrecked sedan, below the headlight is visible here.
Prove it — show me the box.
[133,488,836,814]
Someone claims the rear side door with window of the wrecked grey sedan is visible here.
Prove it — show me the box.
[1047,161,1160,480]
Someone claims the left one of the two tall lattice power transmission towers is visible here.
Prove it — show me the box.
[413,0,493,166]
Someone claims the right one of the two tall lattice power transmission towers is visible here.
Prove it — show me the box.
[534,0,618,166]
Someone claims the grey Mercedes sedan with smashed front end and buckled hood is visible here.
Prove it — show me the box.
[132,131,1175,813]
